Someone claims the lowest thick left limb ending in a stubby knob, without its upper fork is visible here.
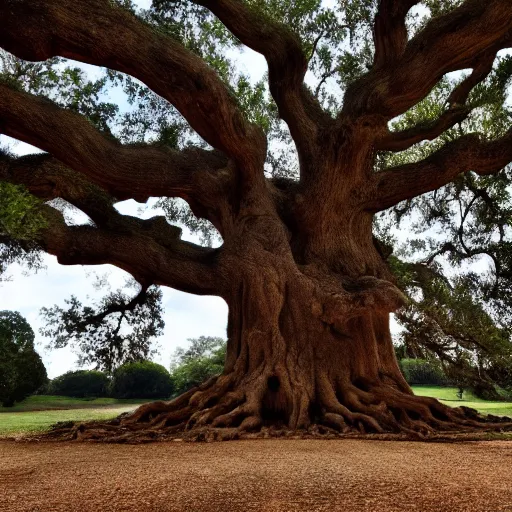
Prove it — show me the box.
[38,206,223,295]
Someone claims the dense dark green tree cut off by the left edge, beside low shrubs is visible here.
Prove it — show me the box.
[0,311,47,407]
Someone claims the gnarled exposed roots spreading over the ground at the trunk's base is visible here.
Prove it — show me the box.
[29,372,512,443]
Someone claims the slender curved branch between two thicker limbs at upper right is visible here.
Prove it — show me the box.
[376,52,496,151]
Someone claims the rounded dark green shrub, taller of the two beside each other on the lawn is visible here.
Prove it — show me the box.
[111,361,172,398]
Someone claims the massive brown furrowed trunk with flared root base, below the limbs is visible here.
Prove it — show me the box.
[64,208,506,441]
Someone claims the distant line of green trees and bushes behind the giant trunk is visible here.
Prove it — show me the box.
[0,311,512,407]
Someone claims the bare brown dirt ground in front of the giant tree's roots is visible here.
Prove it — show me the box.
[0,440,512,512]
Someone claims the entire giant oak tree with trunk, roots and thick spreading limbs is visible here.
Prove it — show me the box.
[0,0,512,438]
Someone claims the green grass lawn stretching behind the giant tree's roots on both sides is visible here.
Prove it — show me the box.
[0,386,512,436]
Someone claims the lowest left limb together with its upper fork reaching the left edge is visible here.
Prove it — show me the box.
[0,150,226,294]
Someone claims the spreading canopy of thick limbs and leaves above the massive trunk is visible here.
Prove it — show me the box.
[0,0,512,400]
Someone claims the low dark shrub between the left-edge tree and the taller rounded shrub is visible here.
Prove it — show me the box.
[48,370,109,398]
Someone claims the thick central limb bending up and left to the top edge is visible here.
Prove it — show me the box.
[193,0,329,167]
